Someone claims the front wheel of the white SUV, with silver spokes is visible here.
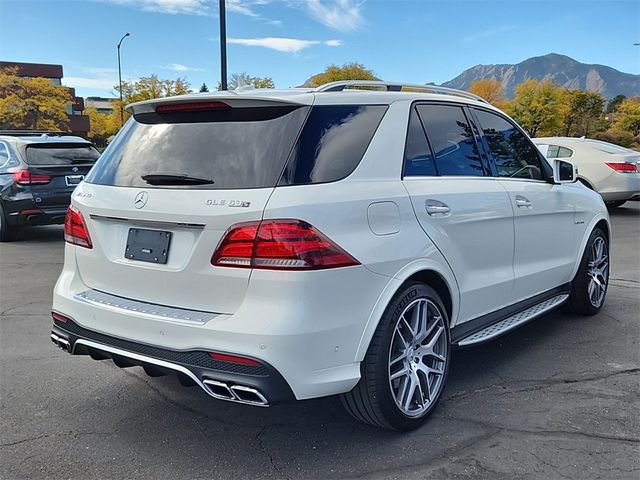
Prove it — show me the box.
[568,228,609,315]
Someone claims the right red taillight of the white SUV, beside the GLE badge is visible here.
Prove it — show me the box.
[211,220,359,270]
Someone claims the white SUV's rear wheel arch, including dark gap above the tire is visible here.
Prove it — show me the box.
[355,259,460,362]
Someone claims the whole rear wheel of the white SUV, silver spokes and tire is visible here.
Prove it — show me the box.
[341,282,451,430]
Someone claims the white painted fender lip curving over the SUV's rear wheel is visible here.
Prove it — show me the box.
[354,258,460,362]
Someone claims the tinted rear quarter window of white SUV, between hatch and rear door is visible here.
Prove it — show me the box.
[280,105,387,185]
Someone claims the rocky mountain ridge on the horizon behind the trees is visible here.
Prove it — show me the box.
[442,53,640,98]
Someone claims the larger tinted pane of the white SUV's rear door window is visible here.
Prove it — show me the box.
[418,105,484,175]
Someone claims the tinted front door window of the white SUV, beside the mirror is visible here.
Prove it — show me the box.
[476,110,553,180]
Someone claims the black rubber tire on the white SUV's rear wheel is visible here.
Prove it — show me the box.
[341,282,451,431]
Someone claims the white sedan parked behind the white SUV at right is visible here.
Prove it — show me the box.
[533,137,640,207]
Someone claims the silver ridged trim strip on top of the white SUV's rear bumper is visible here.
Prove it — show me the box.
[74,289,220,325]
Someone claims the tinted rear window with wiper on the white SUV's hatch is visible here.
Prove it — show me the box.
[87,107,309,189]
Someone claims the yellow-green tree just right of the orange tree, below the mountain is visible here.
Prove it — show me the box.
[507,80,562,137]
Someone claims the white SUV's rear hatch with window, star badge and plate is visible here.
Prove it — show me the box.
[74,96,312,313]
